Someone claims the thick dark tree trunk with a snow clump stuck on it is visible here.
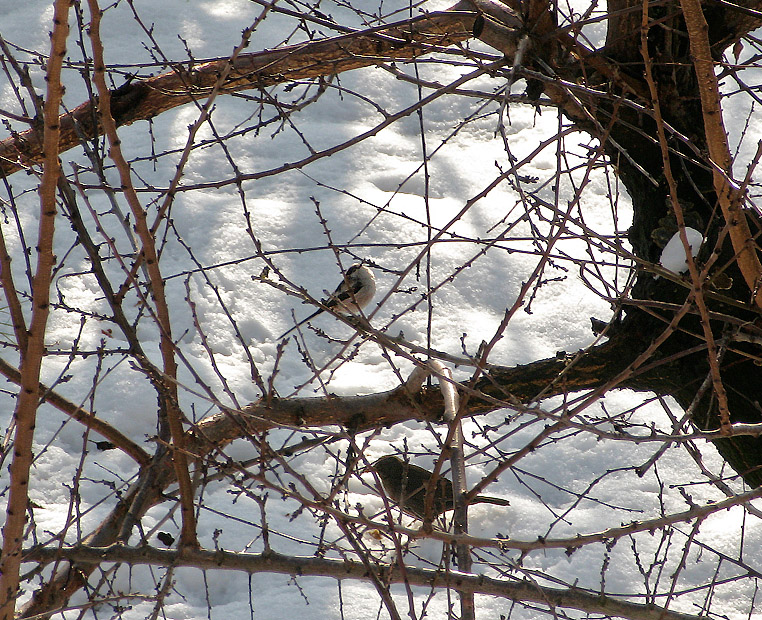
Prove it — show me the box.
[599,0,762,486]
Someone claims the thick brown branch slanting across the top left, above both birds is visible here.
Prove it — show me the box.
[0,0,478,176]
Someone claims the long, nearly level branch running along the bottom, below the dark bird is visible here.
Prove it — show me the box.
[25,545,703,620]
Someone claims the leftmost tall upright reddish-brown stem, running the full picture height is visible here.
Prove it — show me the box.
[0,0,69,620]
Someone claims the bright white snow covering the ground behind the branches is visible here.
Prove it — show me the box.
[0,0,762,620]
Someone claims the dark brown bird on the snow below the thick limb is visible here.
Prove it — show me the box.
[373,456,510,519]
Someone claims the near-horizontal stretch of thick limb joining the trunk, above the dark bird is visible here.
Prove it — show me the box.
[188,336,685,456]
